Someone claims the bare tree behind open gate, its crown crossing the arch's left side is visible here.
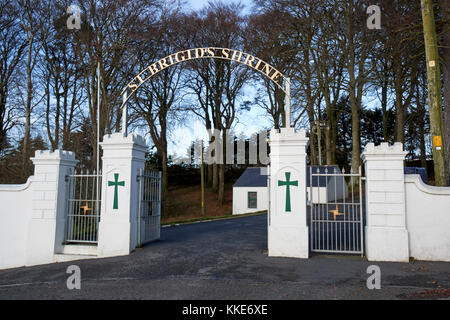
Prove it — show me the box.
[132,7,184,216]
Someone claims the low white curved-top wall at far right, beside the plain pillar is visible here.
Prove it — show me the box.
[405,175,450,261]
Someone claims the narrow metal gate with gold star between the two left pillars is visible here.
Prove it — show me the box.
[64,171,102,244]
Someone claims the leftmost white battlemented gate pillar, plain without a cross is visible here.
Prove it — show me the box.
[26,150,78,265]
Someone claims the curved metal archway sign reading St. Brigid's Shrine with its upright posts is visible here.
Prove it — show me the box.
[121,47,291,135]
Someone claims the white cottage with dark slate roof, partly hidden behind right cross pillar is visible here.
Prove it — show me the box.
[233,166,348,214]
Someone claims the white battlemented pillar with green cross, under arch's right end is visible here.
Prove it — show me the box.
[268,128,309,258]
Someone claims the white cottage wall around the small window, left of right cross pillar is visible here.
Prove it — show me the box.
[233,187,269,214]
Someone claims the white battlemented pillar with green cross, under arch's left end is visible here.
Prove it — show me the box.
[98,133,147,257]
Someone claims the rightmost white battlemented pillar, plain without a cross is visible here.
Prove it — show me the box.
[361,142,409,262]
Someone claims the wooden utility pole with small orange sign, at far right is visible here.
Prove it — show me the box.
[421,0,446,186]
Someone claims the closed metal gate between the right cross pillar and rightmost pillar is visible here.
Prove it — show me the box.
[307,166,365,255]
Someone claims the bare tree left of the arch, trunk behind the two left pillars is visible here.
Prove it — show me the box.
[74,0,155,169]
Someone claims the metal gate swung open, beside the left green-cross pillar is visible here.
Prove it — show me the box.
[137,169,161,246]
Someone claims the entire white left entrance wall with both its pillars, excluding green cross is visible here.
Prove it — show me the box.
[0,133,147,269]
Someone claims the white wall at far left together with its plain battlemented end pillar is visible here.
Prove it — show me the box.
[0,150,78,269]
